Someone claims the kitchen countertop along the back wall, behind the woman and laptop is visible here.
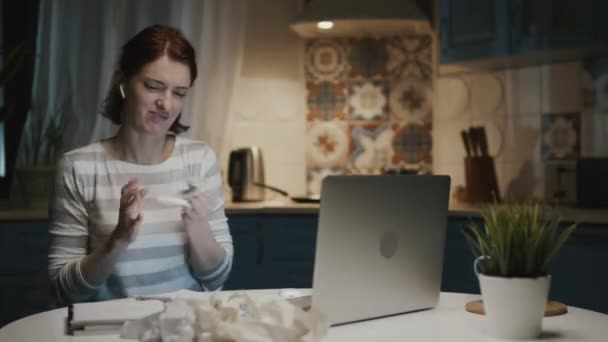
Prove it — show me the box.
[0,199,608,224]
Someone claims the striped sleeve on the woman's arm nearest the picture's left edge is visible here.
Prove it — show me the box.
[48,156,95,304]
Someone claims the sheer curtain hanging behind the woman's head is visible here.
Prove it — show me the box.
[26,0,246,158]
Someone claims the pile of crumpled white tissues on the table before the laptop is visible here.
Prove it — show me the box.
[120,293,329,342]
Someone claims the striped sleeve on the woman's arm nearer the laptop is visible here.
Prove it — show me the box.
[194,145,234,290]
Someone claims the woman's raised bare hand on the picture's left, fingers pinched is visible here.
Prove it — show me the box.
[111,179,146,244]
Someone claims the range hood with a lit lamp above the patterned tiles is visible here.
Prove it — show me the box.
[290,0,430,38]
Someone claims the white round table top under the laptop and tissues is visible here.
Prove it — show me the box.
[0,290,608,342]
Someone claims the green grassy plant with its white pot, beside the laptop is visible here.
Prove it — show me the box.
[464,202,575,339]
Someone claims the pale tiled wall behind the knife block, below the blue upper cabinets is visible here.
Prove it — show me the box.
[433,61,608,203]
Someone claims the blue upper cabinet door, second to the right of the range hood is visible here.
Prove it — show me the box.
[509,0,604,55]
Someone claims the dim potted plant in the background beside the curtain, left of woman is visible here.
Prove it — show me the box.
[16,99,71,209]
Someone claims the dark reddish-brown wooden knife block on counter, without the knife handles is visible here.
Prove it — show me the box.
[464,156,500,203]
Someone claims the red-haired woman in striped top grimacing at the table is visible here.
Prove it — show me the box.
[49,25,233,303]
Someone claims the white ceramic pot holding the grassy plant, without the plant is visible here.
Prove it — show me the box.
[479,274,551,340]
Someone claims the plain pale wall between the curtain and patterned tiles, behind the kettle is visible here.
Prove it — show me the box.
[220,0,306,194]
